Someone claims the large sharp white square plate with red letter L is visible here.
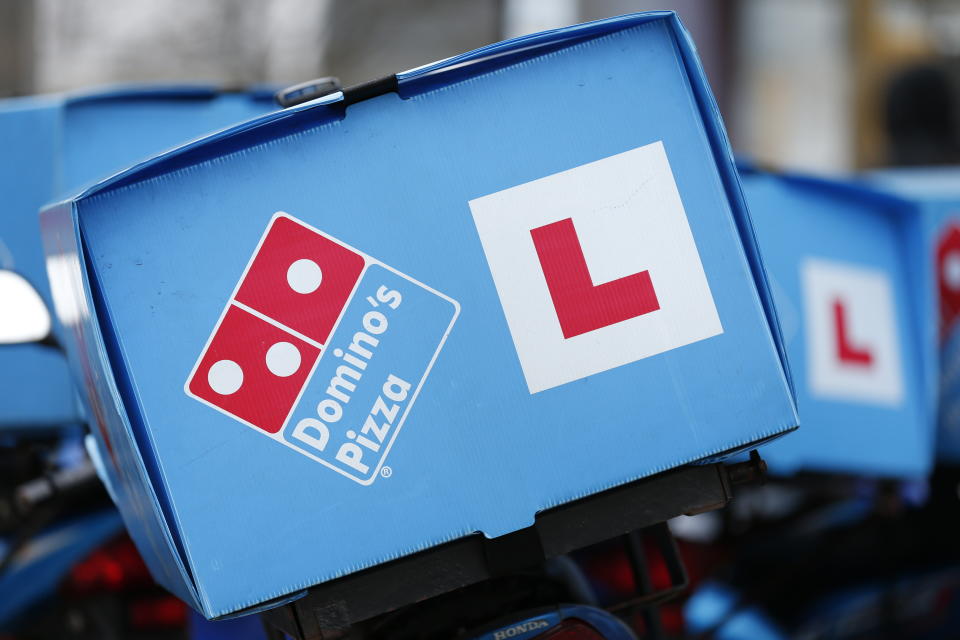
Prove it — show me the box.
[470,142,723,393]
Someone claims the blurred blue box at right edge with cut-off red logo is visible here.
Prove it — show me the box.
[864,167,960,464]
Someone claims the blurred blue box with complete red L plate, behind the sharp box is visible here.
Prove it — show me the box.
[741,167,934,477]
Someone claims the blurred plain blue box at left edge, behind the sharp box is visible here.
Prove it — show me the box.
[0,86,273,428]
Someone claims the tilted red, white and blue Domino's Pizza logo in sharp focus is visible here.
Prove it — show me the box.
[184,212,460,485]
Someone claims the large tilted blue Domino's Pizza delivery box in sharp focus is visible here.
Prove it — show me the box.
[42,12,798,617]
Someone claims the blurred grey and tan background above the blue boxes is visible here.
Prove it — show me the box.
[0,0,960,172]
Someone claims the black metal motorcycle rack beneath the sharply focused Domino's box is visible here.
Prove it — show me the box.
[261,451,766,640]
